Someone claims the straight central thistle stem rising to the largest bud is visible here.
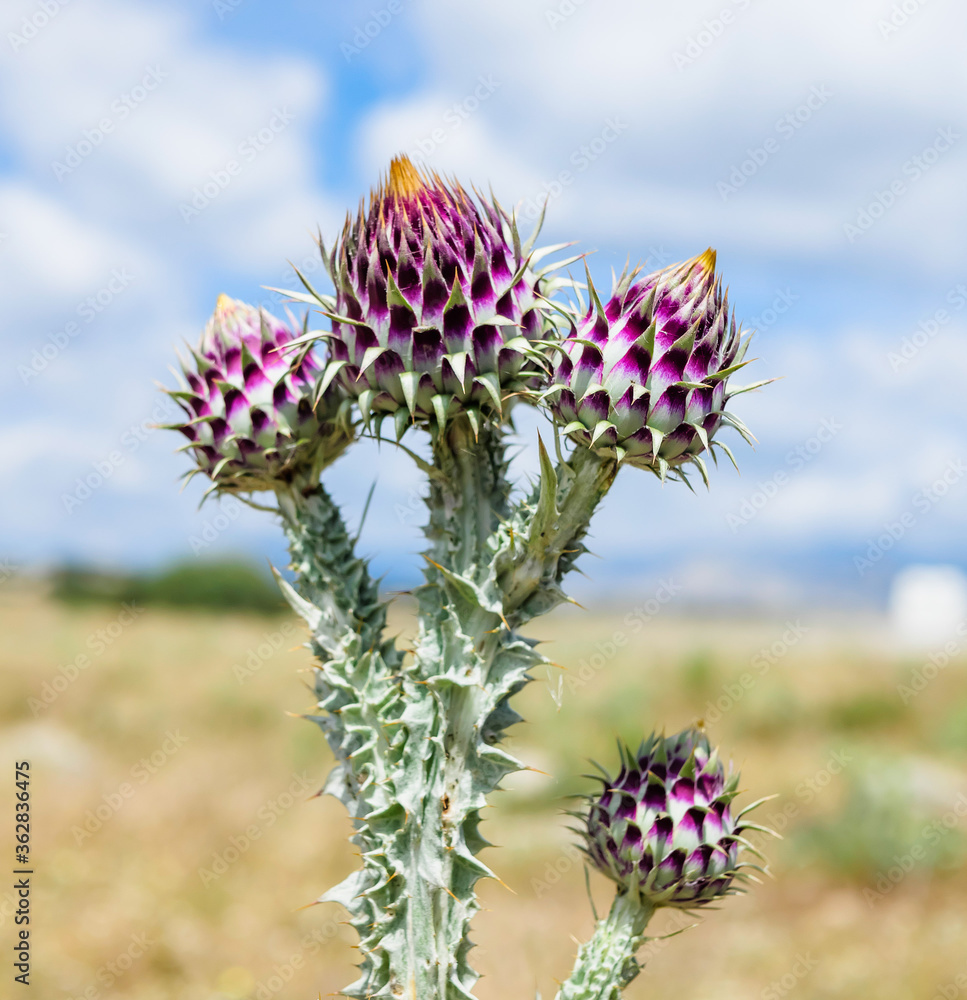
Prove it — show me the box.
[391,416,514,1000]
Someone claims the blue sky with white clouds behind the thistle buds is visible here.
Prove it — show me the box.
[0,0,967,603]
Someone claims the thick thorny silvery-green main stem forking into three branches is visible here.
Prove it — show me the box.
[279,416,630,1000]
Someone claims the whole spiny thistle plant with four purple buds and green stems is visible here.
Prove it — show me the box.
[163,157,776,1000]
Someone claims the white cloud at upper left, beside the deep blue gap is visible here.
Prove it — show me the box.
[0,0,334,282]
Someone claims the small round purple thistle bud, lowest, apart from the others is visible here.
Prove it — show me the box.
[584,729,761,909]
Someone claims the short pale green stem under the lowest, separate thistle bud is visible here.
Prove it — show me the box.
[557,892,655,1000]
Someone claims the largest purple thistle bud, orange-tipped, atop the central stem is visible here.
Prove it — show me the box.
[325,156,546,435]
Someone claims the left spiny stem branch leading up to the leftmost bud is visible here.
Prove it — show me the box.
[278,483,414,996]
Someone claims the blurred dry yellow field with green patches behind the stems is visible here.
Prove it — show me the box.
[0,581,967,1000]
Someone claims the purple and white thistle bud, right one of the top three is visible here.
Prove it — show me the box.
[546,250,764,483]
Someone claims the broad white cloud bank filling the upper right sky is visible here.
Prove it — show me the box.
[346,0,967,268]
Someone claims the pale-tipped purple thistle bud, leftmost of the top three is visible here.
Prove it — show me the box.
[168,295,352,492]
